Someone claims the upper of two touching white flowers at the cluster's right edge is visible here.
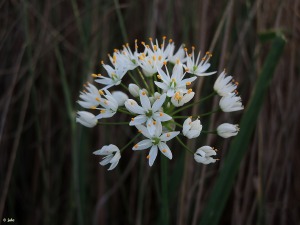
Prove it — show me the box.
[214,70,237,96]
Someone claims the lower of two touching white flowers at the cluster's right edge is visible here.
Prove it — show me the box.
[219,94,244,112]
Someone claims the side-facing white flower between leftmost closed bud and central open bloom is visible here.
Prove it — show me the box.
[96,90,119,119]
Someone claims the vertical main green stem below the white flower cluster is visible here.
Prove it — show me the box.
[160,155,169,225]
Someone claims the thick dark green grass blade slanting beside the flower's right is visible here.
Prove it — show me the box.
[200,35,285,225]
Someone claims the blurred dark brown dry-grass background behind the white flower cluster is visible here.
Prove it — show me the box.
[0,0,300,225]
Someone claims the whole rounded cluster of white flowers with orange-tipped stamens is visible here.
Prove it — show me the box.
[76,37,243,170]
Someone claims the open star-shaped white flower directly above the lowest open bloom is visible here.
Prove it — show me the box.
[125,91,172,135]
